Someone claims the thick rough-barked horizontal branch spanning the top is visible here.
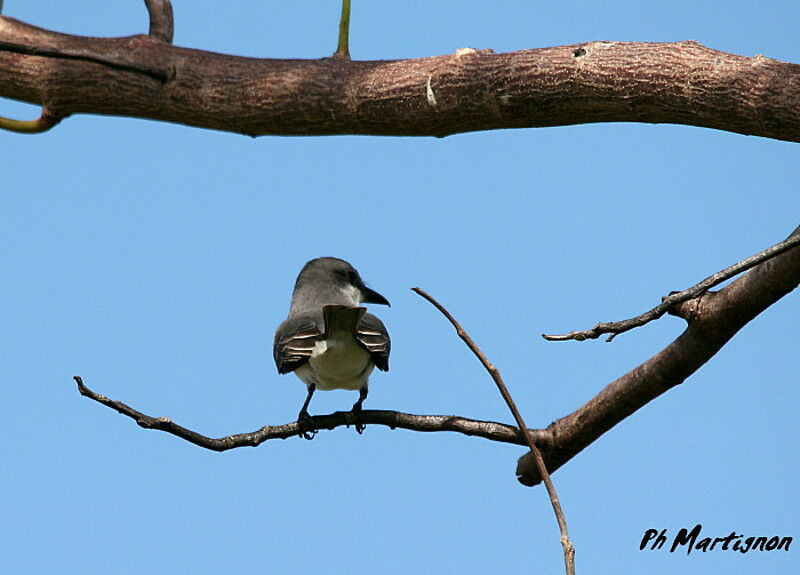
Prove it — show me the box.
[0,17,800,142]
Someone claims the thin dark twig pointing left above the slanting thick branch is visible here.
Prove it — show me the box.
[542,236,800,342]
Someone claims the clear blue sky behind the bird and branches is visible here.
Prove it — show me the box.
[0,0,800,575]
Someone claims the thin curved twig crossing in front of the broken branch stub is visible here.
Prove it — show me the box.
[411,287,575,575]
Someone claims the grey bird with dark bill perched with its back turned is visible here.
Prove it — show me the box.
[273,258,391,439]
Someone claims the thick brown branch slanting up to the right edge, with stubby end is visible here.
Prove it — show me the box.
[517,227,800,485]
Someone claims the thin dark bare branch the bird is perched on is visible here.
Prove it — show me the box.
[73,376,547,451]
